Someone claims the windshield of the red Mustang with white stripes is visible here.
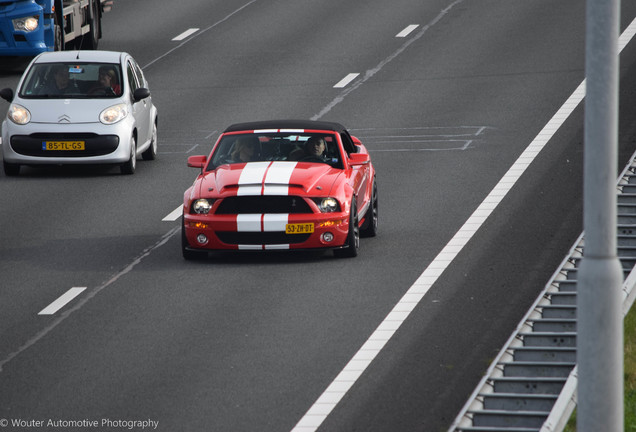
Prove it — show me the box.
[207,132,343,170]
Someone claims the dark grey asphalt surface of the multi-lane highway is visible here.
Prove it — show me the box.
[0,0,636,432]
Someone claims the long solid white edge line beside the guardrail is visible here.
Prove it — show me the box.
[292,11,636,432]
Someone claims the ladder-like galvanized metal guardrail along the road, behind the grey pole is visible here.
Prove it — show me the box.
[449,148,636,432]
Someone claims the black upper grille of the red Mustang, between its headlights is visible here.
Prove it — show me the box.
[216,195,312,214]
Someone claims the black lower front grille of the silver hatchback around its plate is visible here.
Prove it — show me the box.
[11,133,119,157]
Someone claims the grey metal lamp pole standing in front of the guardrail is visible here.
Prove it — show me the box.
[577,0,624,432]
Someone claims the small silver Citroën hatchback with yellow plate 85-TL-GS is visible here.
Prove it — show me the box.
[0,51,157,176]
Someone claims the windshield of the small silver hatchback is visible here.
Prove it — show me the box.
[20,63,122,99]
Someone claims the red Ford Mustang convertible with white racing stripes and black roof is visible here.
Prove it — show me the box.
[181,120,378,259]
